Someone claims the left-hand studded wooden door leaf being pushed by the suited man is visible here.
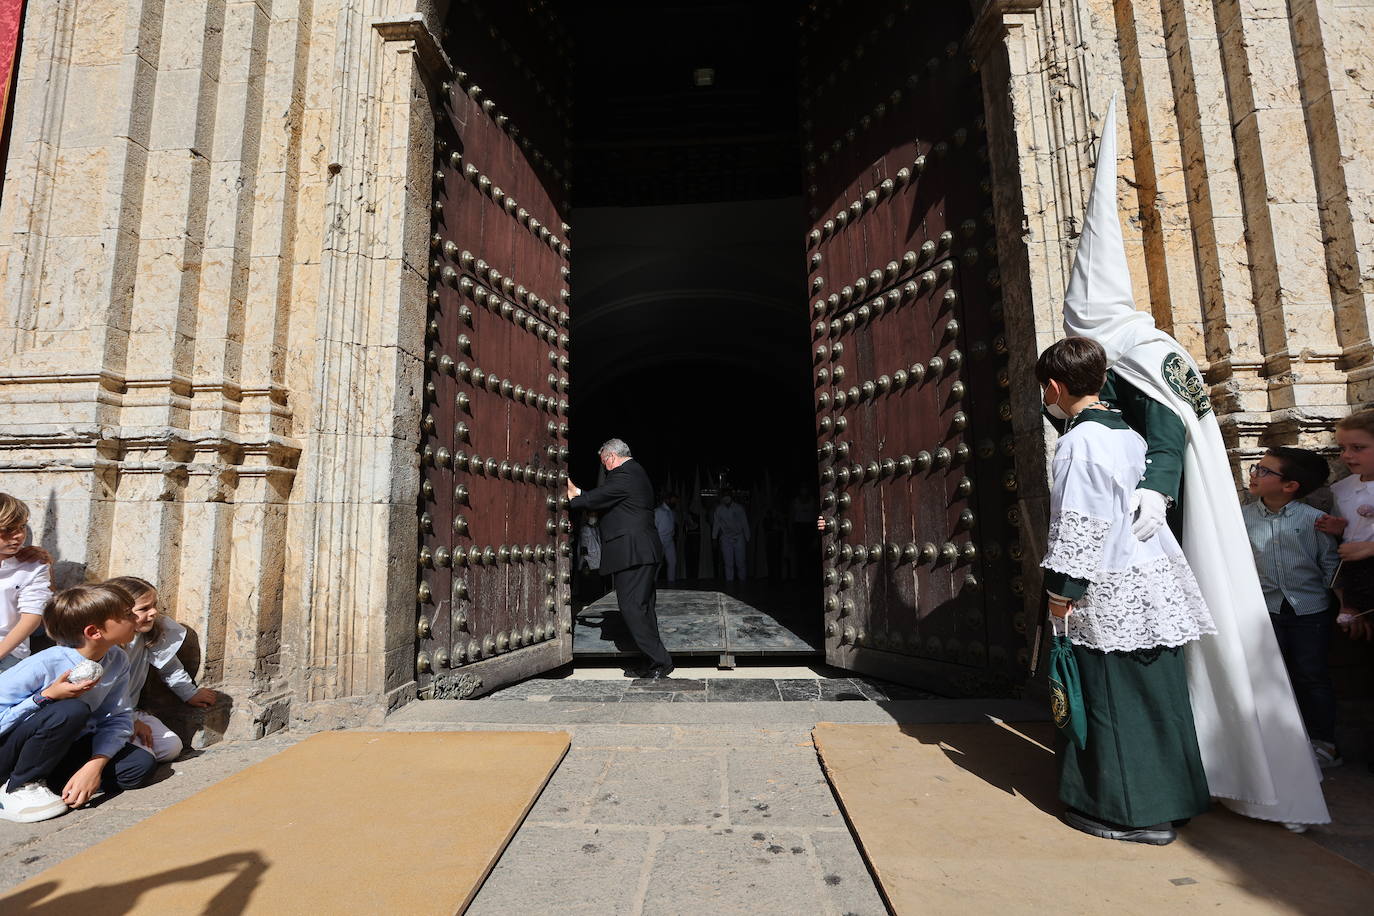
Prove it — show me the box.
[416,3,572,698]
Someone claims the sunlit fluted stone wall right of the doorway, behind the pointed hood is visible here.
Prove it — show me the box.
[970,0,1374,612]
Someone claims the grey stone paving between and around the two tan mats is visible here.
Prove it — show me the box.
[0,672,1374,916]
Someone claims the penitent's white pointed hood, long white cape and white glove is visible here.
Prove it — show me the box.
[1063,99,1331,827]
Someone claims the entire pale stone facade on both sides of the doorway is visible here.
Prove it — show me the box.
[0,0,1374,735]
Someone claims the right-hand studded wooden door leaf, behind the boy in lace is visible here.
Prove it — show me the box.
[801,0,1025,695]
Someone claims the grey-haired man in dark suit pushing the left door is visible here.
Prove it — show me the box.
[567,439,673,680]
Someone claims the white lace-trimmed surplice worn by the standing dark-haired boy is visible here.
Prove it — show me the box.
[1041,420,1216,652]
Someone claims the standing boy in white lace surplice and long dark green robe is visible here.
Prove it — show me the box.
[1036,338,1216,846]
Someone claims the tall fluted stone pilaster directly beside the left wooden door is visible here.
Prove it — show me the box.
[287,3,447,725]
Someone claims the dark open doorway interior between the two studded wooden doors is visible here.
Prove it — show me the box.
[562,0,822,656]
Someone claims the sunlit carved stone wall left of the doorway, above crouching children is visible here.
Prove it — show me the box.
[0,0,431,737]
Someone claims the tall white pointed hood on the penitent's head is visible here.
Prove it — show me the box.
[1063,96,1168,365]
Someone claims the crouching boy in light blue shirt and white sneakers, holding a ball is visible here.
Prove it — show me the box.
[0,585,157,823]
